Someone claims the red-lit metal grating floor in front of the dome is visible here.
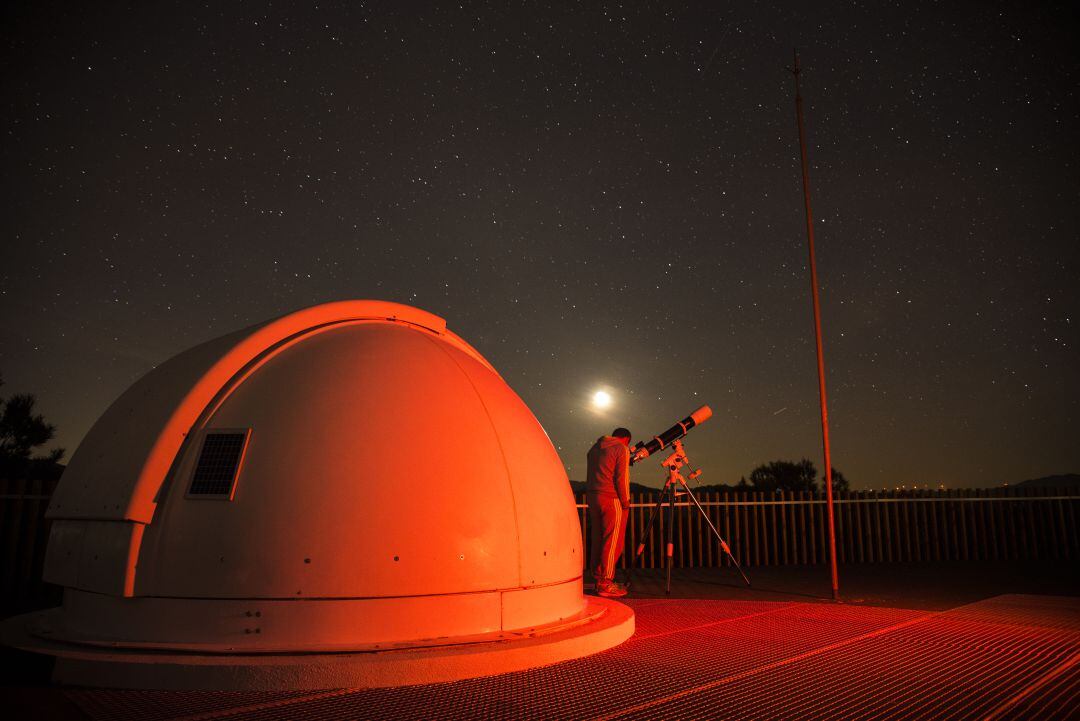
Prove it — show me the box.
[65,596,1080,721]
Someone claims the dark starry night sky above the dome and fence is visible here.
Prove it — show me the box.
[0,1,1080,488]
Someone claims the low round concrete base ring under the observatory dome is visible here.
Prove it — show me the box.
[0,597,634,691]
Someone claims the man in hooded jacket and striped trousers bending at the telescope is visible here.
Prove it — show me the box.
[585,428,630,598]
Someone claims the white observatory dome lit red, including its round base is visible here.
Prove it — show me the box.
[6,301,633,688]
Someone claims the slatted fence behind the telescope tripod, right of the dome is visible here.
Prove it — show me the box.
[578,488,1080,568]
